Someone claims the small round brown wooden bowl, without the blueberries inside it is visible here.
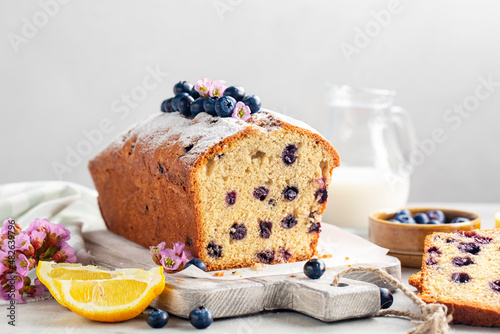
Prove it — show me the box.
[368,208,481,268]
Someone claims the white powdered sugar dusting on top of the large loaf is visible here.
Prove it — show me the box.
[106,109,324,164]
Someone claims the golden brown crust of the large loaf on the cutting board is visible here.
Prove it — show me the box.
[89,111,339,270]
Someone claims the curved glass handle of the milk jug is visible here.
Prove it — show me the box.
[390,106,417,176]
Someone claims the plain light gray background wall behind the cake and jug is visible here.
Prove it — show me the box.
[0,0,500,202]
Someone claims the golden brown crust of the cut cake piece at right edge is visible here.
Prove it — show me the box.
[408,229,500,327]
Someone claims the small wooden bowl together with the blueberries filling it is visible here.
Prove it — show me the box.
[368,207,481,268]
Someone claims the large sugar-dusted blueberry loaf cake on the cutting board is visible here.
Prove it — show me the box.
[89,110,339,270]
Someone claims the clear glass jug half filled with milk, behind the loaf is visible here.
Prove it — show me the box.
[323,85,416,234]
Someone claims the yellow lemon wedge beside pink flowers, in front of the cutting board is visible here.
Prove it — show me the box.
[37,263,165,322]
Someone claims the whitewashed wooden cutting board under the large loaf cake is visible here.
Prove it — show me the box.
[84,230,401,321]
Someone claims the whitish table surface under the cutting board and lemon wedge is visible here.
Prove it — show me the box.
[0,203,500,334]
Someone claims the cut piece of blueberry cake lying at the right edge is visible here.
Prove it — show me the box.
[409,229,500,326]
